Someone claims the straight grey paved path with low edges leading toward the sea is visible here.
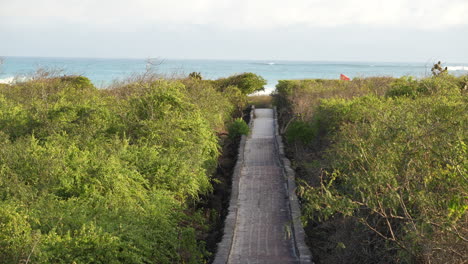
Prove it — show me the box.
[214,109,308,264]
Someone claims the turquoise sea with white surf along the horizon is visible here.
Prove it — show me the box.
[0,57,468,92]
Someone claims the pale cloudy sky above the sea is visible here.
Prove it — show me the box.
[0,0,468,62]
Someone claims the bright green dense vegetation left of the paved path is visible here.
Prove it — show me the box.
[0,71,261,263]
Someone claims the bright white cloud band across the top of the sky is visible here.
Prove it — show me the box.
[0,0,468,30]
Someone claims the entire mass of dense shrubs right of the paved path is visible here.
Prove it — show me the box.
[276,73,468,263]
